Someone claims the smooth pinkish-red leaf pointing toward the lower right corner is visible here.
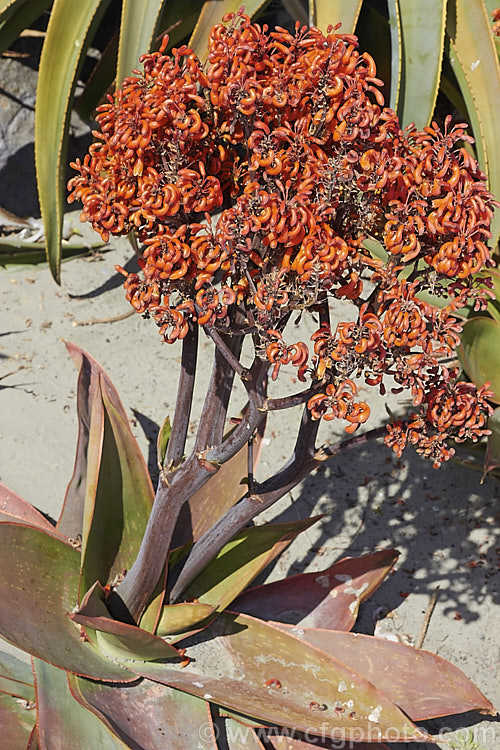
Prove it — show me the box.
[277,623,497,721]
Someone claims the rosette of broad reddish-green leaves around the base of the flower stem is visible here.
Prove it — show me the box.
[0,344,494,750]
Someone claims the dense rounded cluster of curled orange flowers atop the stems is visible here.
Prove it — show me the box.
[69,12,495,464]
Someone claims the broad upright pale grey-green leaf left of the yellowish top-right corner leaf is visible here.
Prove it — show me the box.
[398,0,446,130]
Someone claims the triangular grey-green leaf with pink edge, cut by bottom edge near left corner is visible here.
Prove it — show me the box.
[33,659,130,750]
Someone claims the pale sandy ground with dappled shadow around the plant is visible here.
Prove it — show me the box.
[0,220,500,750]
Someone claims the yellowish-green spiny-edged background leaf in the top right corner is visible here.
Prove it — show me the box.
[448,0,500,244]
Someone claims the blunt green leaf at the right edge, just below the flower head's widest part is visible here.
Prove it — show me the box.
[458,318,500,403]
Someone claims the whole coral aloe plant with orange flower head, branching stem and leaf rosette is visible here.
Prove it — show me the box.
[0,12,495,750]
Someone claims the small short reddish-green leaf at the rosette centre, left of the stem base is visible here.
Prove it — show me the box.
[69,582,179,661]
